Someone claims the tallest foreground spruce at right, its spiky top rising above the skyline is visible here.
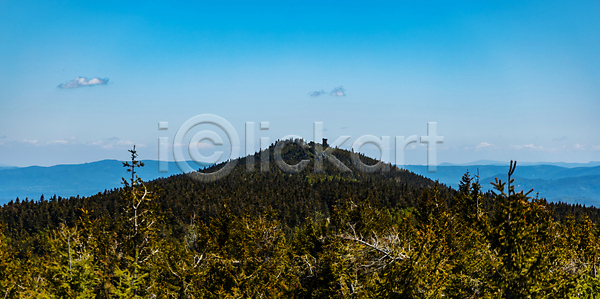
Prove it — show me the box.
[488,161,569,298]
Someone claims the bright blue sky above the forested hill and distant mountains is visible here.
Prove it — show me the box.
[0,1,600,166]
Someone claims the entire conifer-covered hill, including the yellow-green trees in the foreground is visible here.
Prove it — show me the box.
[0,143,600,298]
